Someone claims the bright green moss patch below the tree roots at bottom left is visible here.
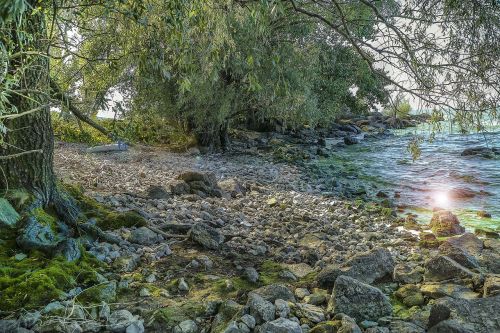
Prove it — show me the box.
[0,247,103,311]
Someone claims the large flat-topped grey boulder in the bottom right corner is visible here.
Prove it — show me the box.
[429,296,500,333]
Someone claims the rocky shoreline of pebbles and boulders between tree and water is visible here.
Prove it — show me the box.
[0,133,500,333]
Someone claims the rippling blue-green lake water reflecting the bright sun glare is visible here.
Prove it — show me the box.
[319,120,500,231]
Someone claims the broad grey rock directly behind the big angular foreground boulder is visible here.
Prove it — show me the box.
[317,248,394,288]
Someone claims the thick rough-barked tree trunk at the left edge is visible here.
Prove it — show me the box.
[0,0,56,205]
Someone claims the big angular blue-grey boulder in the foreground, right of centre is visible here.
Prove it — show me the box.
[330,275,392,321]
